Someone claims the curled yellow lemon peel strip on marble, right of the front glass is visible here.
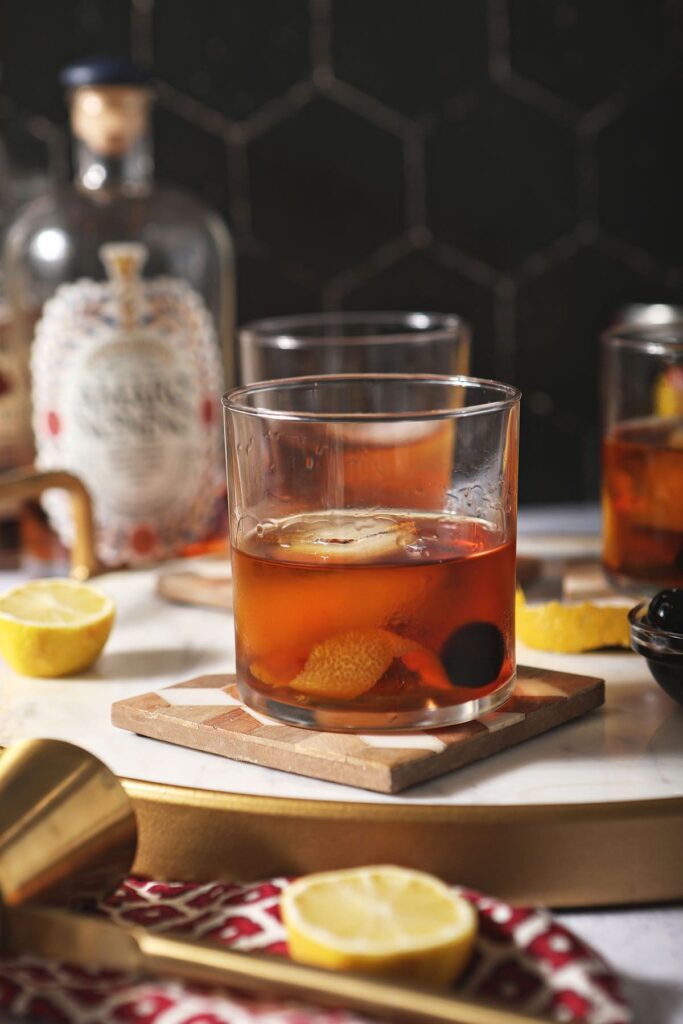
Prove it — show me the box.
[516,591,631,654]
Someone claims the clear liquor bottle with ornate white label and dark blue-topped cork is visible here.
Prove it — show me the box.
[5,57,234,565]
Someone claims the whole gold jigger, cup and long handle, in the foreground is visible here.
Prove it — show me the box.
[0,739,549,1024]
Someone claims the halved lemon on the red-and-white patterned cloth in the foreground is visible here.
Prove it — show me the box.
[281,865,477,985]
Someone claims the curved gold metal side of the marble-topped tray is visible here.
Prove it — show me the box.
[124,779,683,907]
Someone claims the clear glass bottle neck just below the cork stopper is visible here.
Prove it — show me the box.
[74,133,154,196]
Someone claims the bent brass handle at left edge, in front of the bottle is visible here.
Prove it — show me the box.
[0,466,99,580]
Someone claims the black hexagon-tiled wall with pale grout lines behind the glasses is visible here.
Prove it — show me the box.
[0,0,683,502]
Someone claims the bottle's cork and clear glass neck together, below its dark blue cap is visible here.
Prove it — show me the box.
[71,85,154,197]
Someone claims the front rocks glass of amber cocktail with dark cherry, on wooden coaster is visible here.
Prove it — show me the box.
[224,375,519,730]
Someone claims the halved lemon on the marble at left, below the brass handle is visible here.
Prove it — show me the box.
[0,580,115,676]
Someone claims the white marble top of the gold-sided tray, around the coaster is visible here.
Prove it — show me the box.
[0,562,683,806]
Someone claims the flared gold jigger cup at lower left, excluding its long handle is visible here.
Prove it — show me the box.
[0,739,137,906]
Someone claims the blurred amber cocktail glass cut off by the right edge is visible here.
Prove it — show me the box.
[602,324,683,593]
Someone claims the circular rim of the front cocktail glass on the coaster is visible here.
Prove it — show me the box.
[221,374,521,423]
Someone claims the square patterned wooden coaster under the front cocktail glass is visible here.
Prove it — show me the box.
[112,667,604,793]
